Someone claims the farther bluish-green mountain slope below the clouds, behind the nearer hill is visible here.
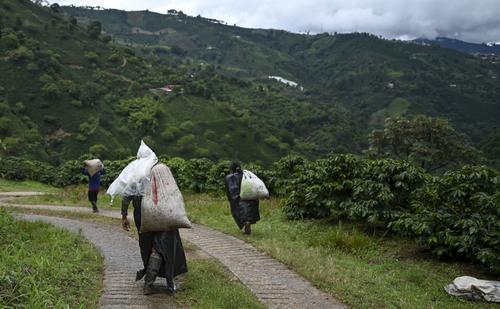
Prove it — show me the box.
[64,7,500,156]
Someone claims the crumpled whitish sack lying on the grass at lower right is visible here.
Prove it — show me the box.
[444,276,500,303]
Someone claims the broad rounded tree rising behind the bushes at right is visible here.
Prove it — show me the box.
[367,115,483,172]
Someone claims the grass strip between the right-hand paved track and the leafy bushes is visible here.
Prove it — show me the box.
[187,195,494,308]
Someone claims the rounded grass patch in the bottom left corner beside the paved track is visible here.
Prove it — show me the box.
[0,209,103,308]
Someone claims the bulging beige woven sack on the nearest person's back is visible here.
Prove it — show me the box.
[140,164,191,233]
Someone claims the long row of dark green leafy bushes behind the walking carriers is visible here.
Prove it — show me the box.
[0,154,500,267]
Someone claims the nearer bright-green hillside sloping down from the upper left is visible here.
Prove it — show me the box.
[0,0,348,163]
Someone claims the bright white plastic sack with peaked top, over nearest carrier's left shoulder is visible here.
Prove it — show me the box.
[106,141,158,196]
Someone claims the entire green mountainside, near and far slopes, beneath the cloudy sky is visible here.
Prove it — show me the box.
[0,0,500,163]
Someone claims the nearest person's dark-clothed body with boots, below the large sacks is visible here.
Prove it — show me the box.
[121,196,187,295]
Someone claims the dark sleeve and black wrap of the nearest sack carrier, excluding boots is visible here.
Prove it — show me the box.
[122,196,187,280]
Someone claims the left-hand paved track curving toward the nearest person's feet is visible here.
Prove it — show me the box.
[16,214,175,309]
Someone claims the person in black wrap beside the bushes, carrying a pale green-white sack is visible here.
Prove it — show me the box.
[224,162,260,234]
